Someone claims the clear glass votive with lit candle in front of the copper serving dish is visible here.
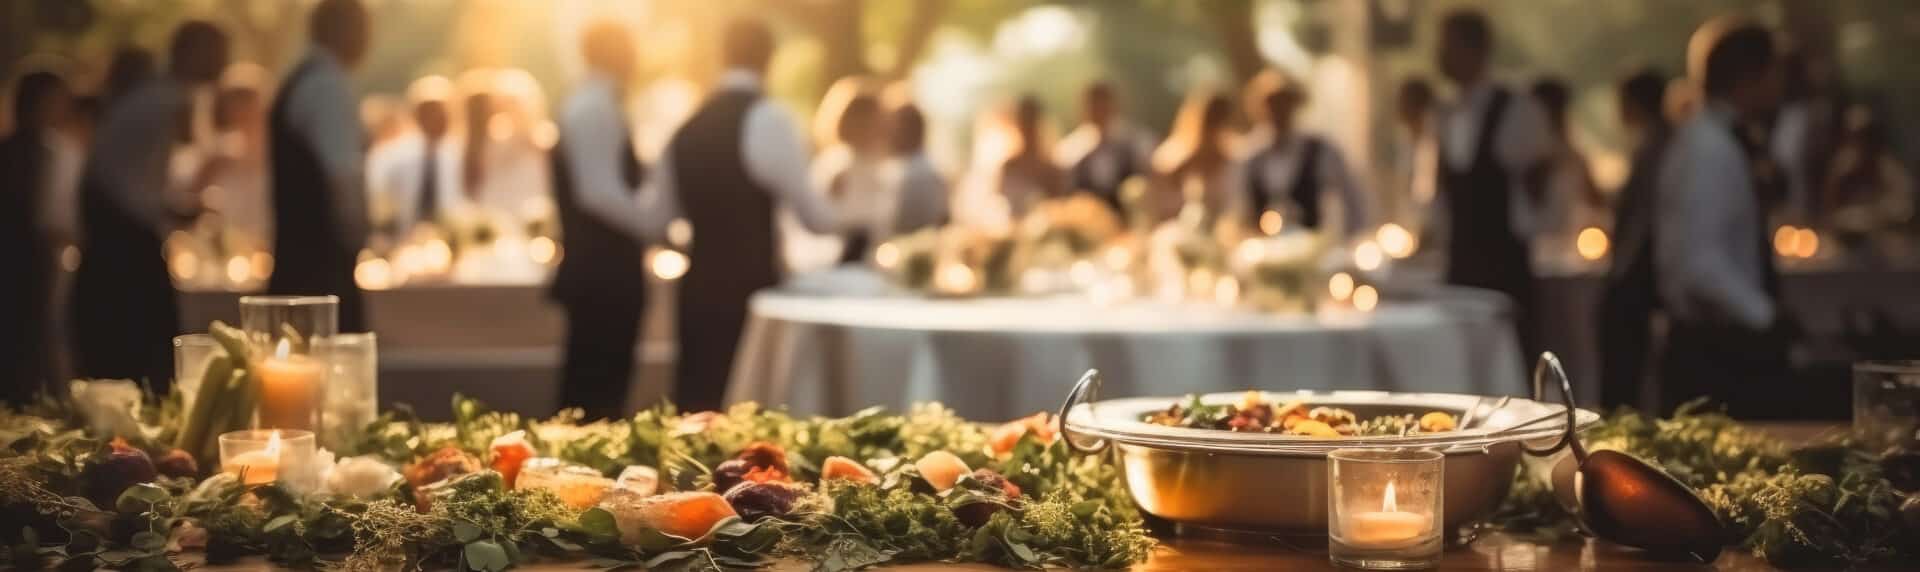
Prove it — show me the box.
[1327,449,1446,570]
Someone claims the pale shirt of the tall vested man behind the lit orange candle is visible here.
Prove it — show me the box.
[280,48,369,244]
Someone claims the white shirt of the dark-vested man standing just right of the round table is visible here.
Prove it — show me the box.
[1440,81,1553,236]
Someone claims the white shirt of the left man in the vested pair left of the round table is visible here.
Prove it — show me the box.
[561,75,648,238]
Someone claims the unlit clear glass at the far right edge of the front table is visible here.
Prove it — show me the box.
[1853,359,1920,453]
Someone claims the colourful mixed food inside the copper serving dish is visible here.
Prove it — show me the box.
[1142,392,1457,438]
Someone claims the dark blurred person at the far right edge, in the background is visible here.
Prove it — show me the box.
[1820,106,1914,236]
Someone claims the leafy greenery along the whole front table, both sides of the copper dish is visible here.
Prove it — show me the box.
[0,395,1920,570]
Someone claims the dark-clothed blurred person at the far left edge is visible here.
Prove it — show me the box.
[0,71,71,403]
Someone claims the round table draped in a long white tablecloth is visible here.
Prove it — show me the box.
[728,270,1526,418]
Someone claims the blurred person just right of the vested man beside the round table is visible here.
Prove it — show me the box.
[1532,77,1607,259]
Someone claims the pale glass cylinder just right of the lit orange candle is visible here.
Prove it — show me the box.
[321,332,380,451]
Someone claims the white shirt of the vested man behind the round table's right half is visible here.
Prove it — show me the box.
[1227,129,1371,236]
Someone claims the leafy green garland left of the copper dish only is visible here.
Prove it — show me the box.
[0,395,1154,570]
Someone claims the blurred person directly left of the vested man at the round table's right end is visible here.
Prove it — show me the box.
[1380,77,1440,230]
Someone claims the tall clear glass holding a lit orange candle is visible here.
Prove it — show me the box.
[240,296,340,430]
